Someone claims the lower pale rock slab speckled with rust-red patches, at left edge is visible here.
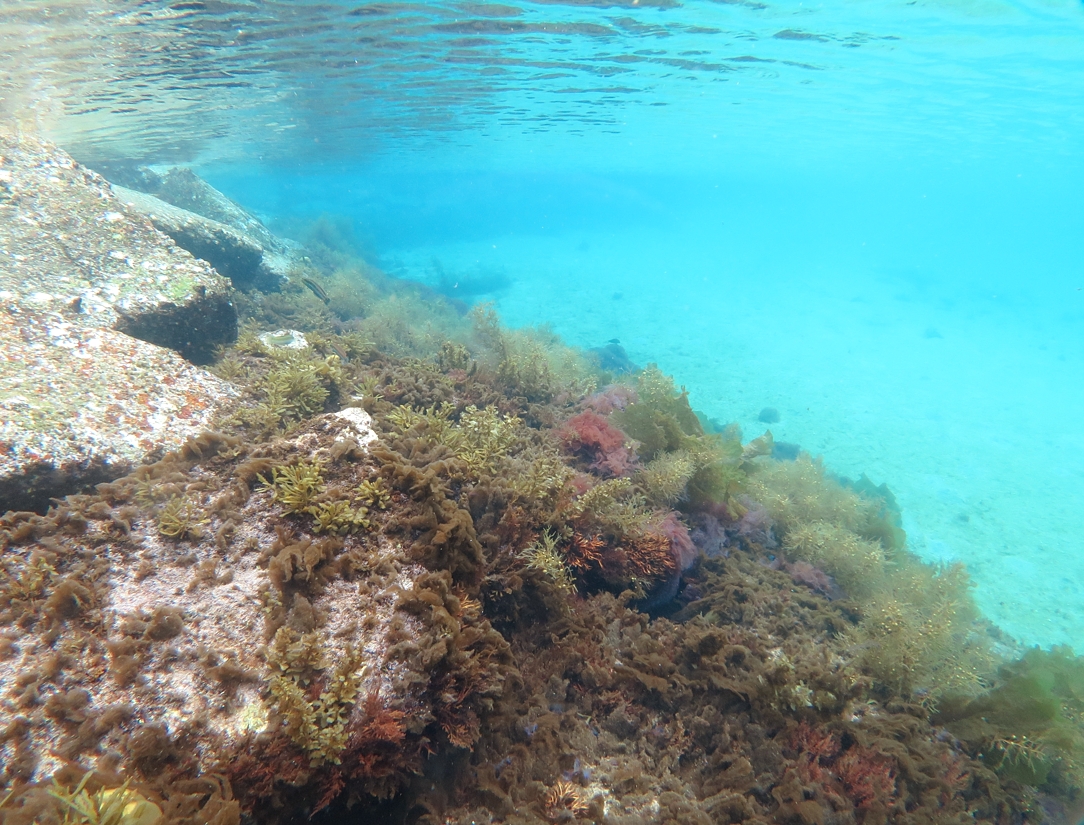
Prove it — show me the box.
[0,314,235,513]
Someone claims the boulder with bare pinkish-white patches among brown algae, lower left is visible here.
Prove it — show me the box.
[0,408,507,821]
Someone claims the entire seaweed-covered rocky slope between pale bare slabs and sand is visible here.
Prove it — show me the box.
[0,166,1084,825]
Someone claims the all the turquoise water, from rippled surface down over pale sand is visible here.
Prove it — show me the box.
[0,0,1084,649]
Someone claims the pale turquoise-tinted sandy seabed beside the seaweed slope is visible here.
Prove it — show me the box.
[395,228,1084,653]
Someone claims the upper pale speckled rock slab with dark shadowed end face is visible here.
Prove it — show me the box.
[0,132,237,363]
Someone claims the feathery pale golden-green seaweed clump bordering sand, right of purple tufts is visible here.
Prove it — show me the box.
[748,455,994,700]
